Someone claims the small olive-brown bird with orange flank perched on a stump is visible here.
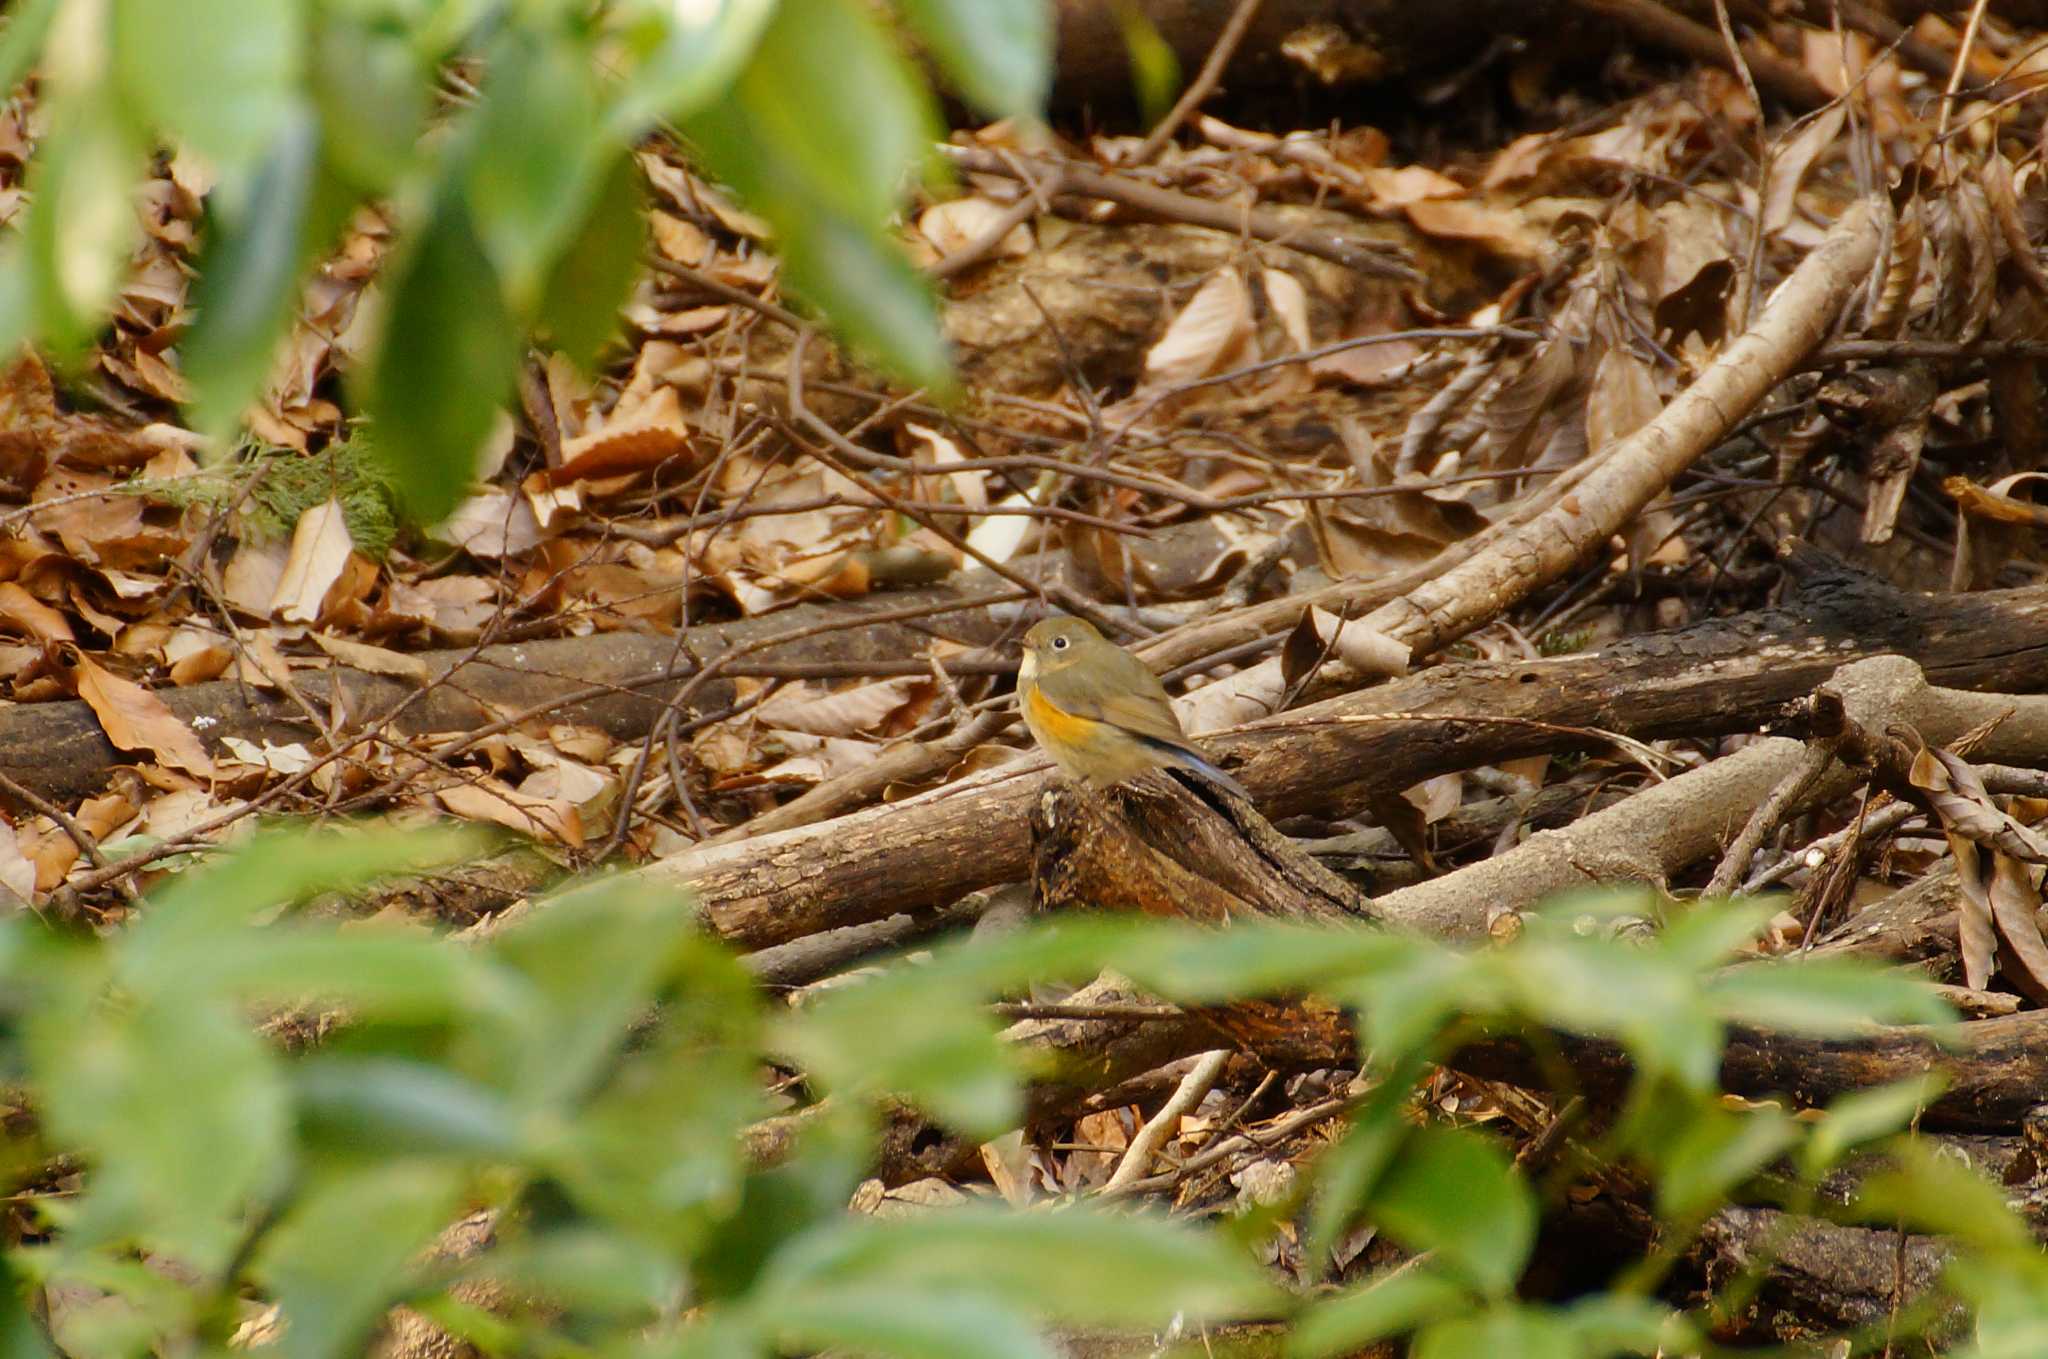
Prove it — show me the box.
[1018,618,1247,798]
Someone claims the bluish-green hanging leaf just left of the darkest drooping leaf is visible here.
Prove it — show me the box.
[178,111,344,438]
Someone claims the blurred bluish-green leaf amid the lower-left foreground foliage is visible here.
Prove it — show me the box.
[293,1056,524,1158]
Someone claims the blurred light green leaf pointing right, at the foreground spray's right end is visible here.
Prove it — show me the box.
[1708,958,1956,1038]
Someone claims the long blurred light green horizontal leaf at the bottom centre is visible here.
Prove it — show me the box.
[756,1208,1278,1326]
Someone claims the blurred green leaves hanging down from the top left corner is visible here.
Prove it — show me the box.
[0,0,1051,522]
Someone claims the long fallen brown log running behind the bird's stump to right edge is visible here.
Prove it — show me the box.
[645,567,2048,950]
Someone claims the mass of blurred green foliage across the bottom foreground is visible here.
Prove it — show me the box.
[0,829,2048,1359]
